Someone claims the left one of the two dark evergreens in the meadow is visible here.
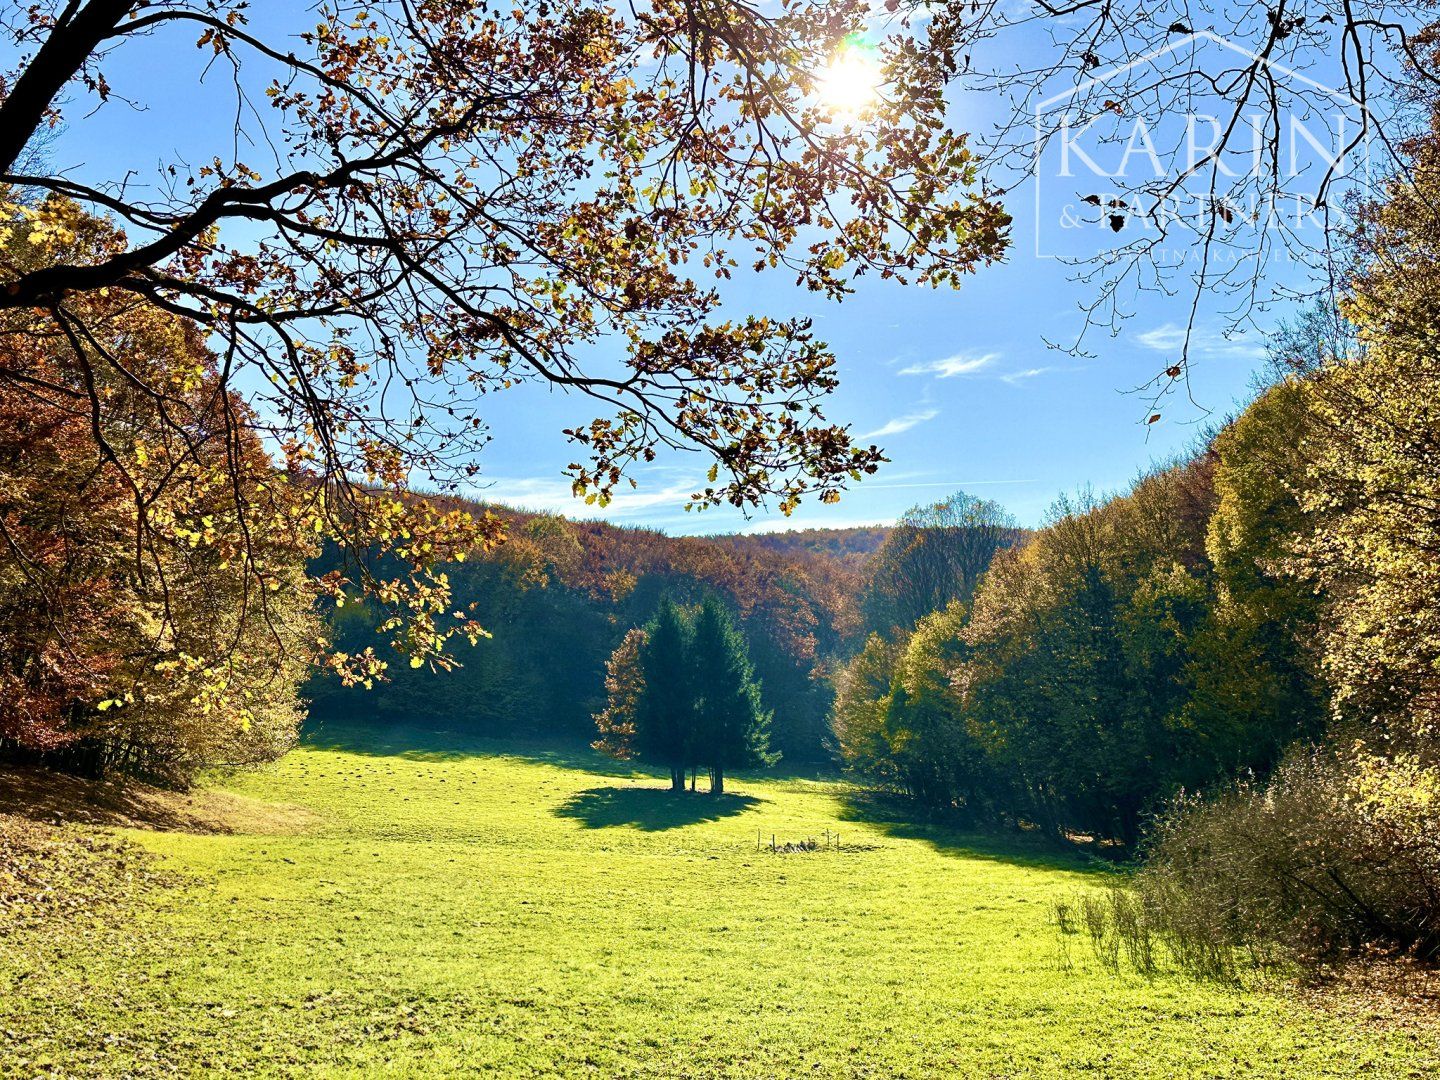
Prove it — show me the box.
[635,598,696,791]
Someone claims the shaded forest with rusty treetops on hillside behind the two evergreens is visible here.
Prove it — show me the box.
[307,507,883,762]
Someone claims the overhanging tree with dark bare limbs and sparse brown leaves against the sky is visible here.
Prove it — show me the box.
[0,0,1007,685]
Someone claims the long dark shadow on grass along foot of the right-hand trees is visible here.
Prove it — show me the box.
[838,788,1115,873]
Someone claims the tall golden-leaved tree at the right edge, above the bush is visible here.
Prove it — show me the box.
[1305,103,1440,749]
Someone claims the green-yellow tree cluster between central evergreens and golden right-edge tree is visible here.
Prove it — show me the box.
[835,400,1326,844]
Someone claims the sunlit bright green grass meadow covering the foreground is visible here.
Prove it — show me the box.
[0,722,1437,1077]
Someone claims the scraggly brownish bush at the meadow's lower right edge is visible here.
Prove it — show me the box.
[1077,752,1440,979]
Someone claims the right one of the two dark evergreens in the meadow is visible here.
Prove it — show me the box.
[690,596,779,795]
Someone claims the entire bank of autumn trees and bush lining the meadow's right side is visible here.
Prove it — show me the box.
[835,84,1440,963]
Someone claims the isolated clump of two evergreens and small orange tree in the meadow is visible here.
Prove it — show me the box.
[593,596,779,795]
